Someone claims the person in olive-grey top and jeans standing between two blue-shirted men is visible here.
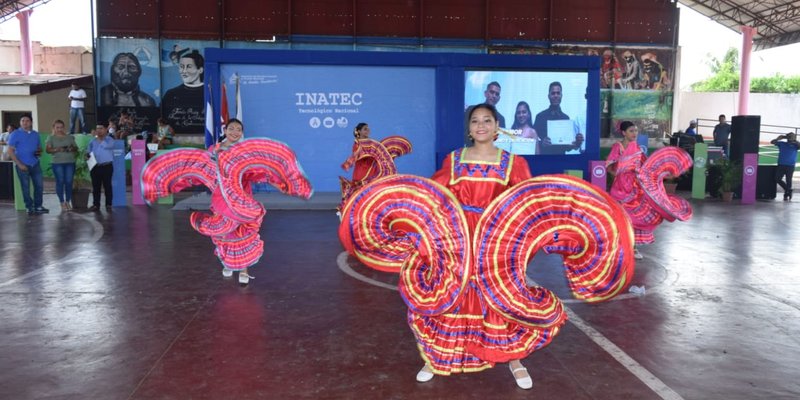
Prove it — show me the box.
[45,119,78,211]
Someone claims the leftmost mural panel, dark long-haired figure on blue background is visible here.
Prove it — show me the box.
[95,38,161,133]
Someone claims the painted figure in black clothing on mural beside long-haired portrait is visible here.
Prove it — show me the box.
[161,49,205,133]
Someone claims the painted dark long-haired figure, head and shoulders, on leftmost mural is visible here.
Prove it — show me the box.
[100,53,156,107]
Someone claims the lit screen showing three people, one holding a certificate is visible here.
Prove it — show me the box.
[464,71,588,155]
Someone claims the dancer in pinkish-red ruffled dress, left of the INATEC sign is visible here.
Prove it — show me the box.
[142,118,313,285]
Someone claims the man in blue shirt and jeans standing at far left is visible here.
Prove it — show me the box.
[8,115,50,215]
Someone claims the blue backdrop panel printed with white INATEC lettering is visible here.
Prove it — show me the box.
[220,64,436,192]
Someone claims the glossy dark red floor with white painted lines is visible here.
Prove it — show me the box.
[0,195,800,399]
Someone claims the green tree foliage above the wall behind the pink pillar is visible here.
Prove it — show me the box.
[692,47,800,93]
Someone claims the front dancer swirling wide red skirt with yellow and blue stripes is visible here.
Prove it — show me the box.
[339,104,633,389]
